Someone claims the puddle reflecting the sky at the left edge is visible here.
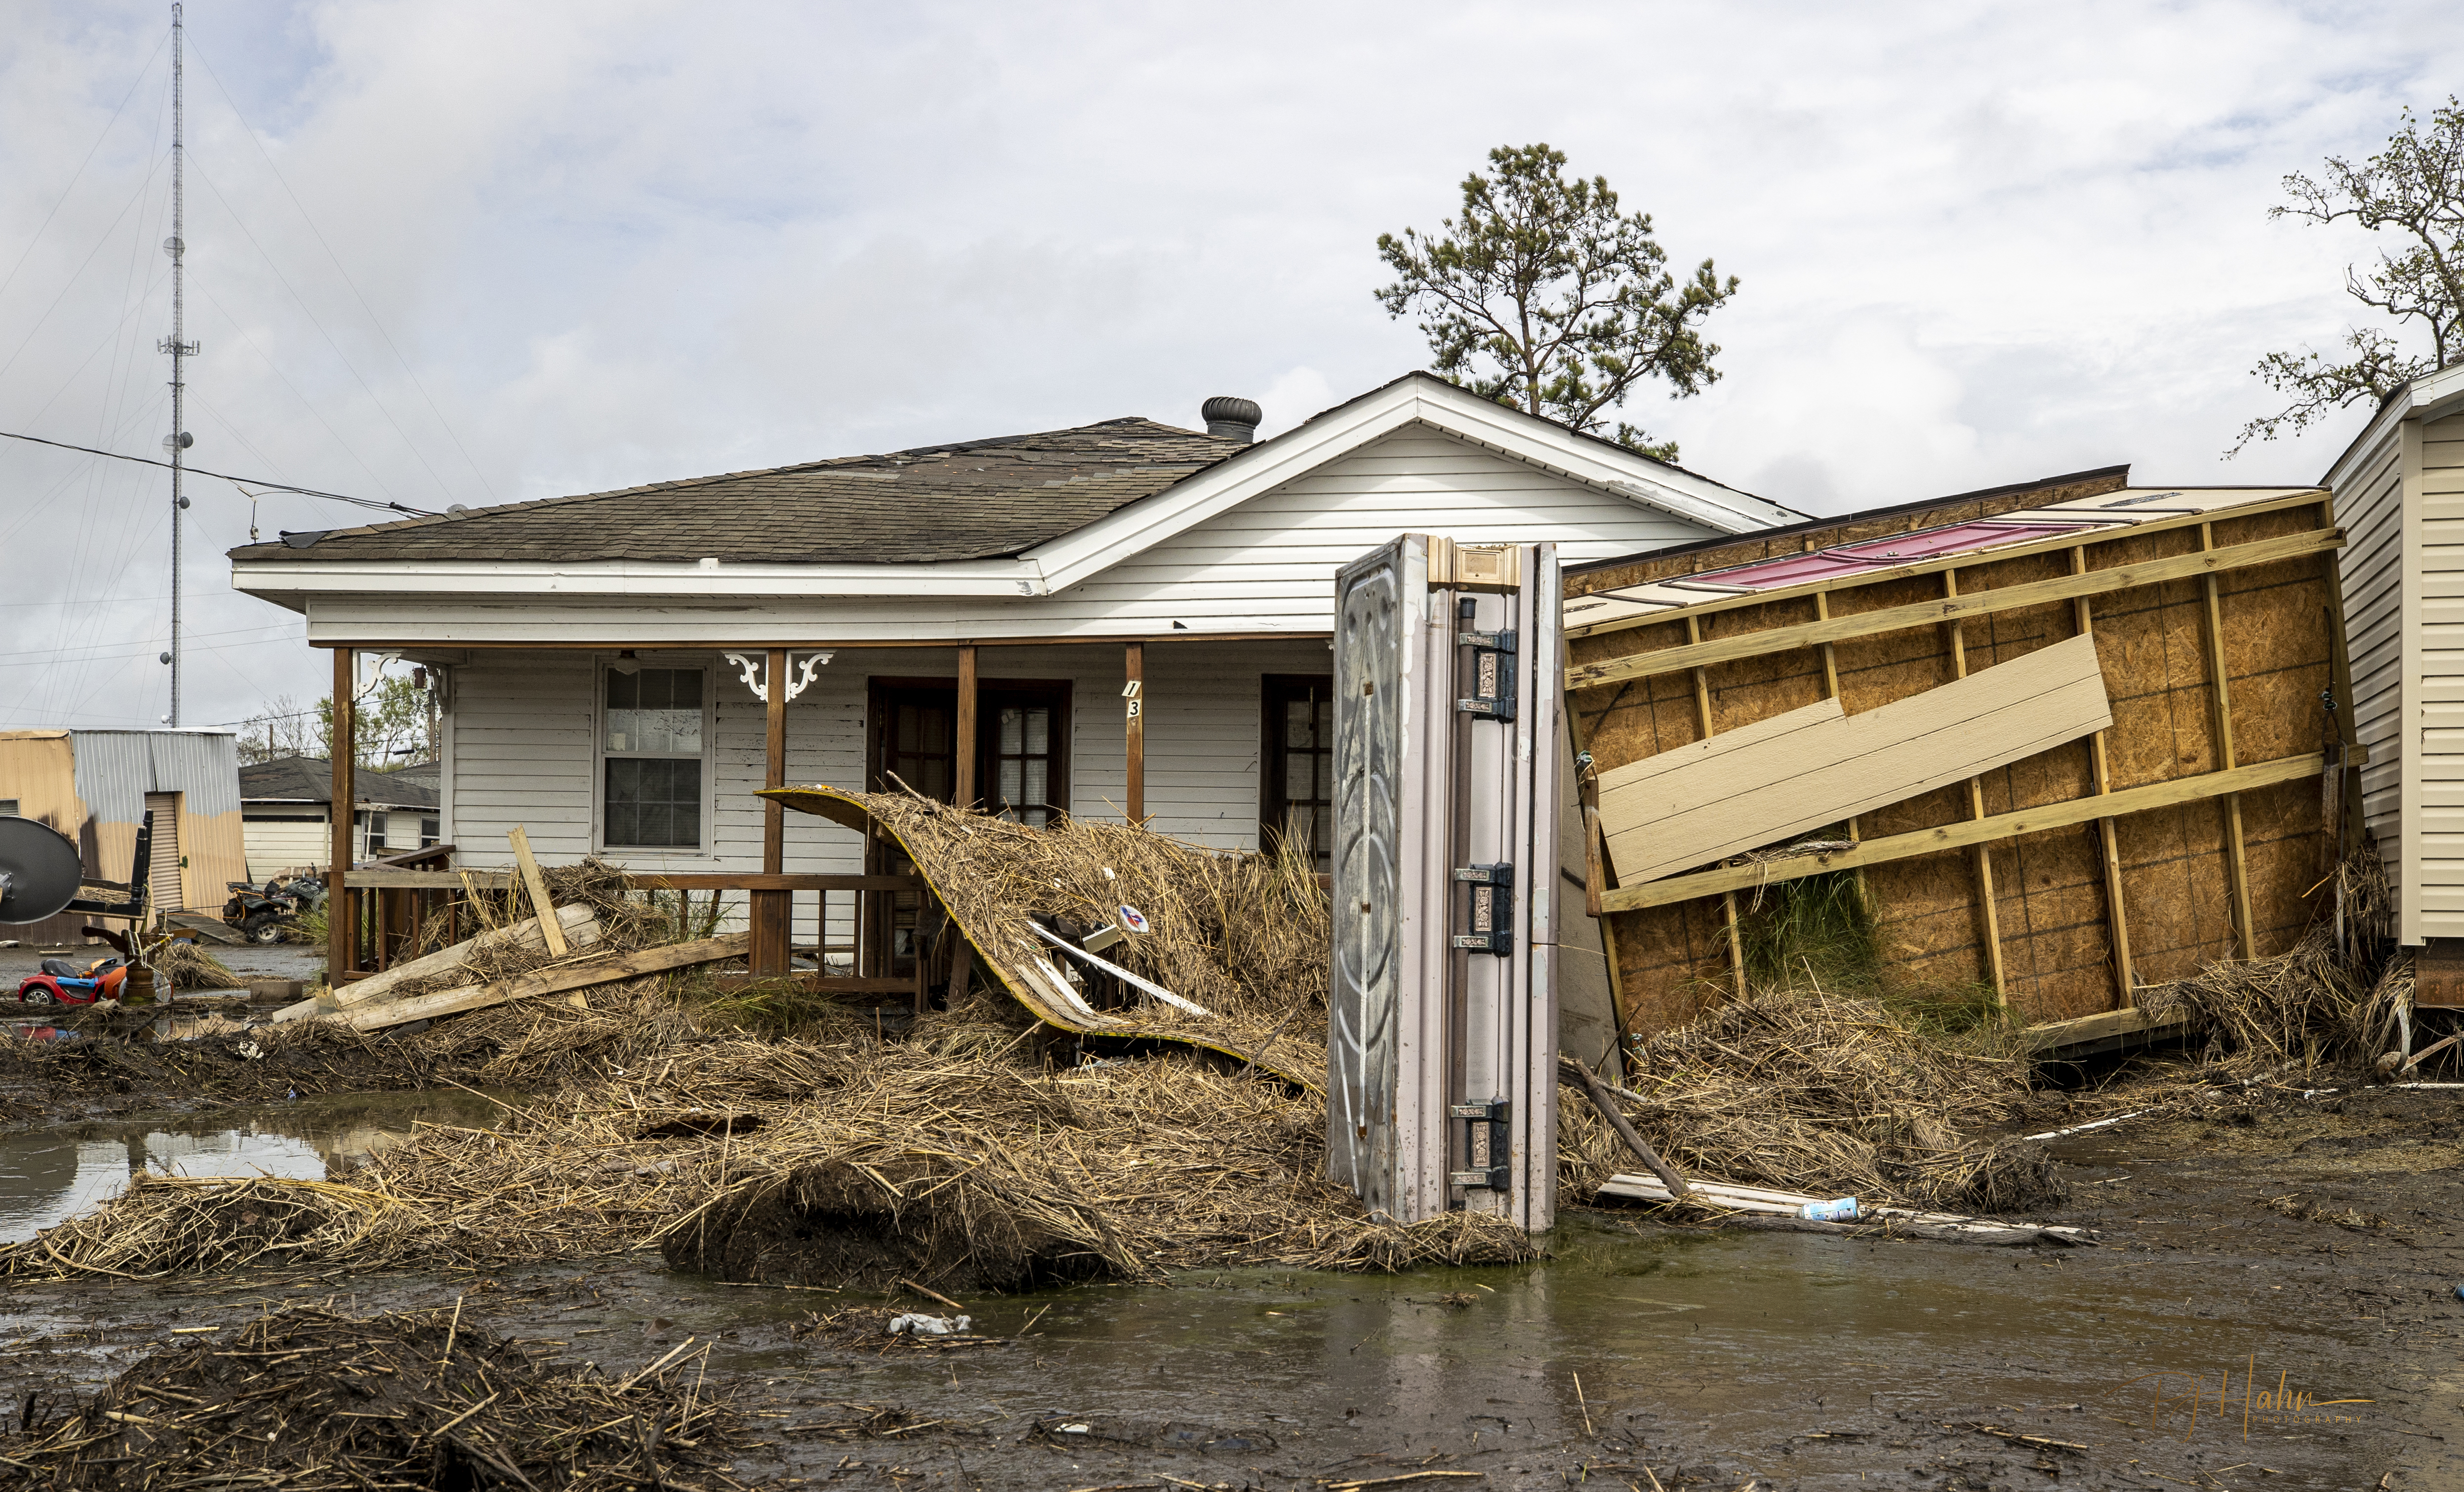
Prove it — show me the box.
[0,1088,520,1244]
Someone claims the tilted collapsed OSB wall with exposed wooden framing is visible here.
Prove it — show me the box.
[1567,485,2358,1048]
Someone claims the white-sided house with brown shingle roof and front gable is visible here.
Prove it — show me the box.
[232,374,1801,1004]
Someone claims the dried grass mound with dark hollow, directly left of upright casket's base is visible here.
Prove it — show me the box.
[660,1054,1537,1292]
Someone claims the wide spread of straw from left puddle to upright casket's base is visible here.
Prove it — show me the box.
[0,997,1535,1290]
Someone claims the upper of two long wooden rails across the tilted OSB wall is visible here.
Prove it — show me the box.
[1565,526,2343,689]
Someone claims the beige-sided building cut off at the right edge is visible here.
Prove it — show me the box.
[2326,364,2464,968]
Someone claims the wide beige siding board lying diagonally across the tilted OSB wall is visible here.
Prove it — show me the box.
[1599,638,2112,887]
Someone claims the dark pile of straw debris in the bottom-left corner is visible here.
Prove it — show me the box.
[5,1310,744,1492]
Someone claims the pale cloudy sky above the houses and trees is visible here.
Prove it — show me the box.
[0,0,2464,726]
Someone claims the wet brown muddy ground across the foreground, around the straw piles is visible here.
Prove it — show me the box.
[0,1049,2464,1492]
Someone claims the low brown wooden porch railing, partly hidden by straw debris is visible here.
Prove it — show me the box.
[330,861,931,1012]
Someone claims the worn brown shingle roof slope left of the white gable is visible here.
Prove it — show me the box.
[232,418,1247,564]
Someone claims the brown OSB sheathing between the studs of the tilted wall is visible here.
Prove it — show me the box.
[1570,497,2334,1032]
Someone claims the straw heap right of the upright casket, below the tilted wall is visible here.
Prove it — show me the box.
[1557,990,2060,1211]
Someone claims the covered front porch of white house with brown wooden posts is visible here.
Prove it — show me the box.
[328,633,1331,1007]
